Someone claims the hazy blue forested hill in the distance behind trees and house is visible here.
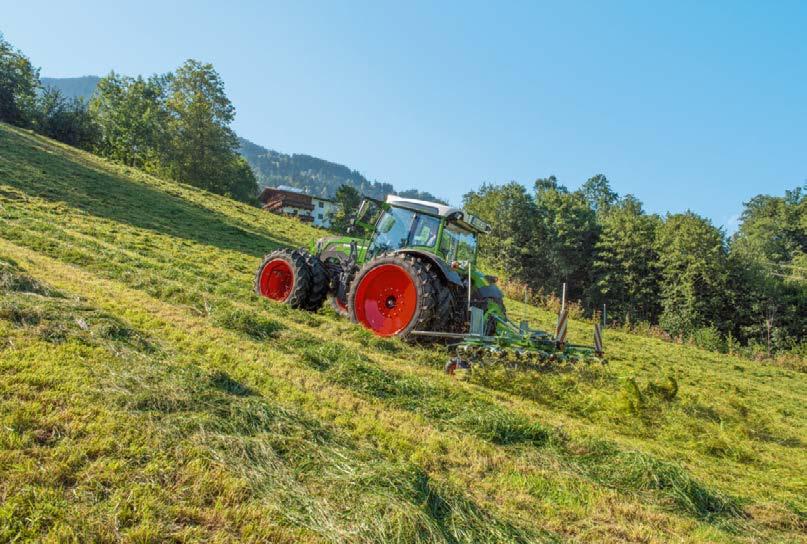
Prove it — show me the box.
[41,76,442,202]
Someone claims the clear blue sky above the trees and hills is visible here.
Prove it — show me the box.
[0,0,807,230]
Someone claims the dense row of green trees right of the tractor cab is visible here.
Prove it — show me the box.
[464,175,807,356]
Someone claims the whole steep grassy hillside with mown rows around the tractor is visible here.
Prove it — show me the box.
[0,125,807,543]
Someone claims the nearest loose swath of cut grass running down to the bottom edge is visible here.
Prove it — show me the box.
[116,365,557,544]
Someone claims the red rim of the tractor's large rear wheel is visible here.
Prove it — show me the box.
[354,264,417,336]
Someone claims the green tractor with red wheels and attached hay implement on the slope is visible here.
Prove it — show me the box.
[255,195,601,371]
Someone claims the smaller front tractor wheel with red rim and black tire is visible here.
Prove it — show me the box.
[254,249,311,308]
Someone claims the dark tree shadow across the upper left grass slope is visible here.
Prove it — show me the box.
[0,127,293,256]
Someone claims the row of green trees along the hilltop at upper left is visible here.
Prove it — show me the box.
[0,35,258,202]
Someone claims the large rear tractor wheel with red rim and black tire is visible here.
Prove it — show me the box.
[348,254,437,336]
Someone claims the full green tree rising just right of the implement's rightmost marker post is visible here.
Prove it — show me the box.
[593,195,661,323]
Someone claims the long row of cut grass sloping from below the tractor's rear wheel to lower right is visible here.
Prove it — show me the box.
[299,338,746,532]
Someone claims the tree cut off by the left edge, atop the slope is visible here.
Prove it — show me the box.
[0,34,40,127]
